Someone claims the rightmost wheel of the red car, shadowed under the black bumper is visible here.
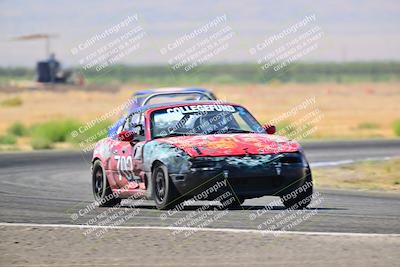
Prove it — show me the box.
[281,171,313,209]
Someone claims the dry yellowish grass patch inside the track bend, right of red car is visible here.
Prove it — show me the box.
[313,159,400,191]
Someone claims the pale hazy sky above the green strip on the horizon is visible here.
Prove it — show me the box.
[0,0,400,66]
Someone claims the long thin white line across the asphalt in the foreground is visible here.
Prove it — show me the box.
[0,223,400,237]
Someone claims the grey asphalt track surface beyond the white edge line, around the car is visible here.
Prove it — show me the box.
[0,140,400,233]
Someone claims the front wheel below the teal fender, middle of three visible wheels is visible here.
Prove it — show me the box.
[152,163,179,210]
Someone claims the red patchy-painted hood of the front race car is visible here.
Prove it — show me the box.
[157,133,300,157]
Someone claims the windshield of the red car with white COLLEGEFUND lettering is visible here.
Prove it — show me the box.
[151,104,264,138]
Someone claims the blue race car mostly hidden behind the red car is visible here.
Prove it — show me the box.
[108,87,217,137]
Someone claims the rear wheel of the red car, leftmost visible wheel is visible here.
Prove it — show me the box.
[92,160,121,207]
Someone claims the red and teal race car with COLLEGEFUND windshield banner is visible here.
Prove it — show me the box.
[92,101,313,209]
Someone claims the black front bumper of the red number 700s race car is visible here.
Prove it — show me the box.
[170,153,311,198]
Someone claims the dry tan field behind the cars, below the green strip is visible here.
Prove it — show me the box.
[0,82,400,139]
